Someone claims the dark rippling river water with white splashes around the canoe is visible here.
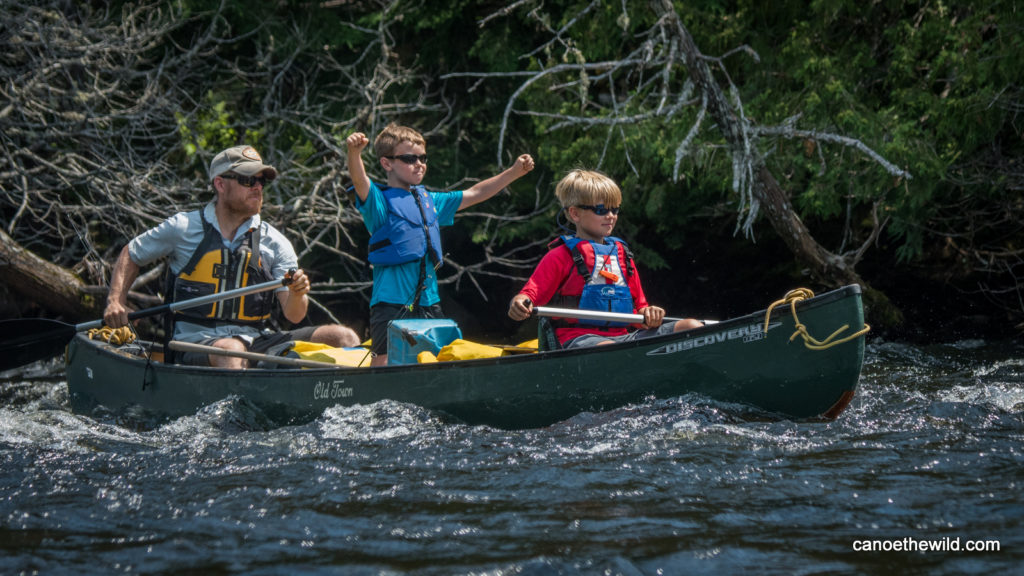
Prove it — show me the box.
[0,339,1024,575]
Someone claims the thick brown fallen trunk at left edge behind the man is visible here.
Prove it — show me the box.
[0,230,102,320]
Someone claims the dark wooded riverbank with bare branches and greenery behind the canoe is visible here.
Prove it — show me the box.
[0,0,1024,340]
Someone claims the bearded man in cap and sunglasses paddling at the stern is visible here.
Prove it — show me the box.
[103,146,359,369]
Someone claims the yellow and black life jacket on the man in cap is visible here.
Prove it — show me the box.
[167,210,275,324]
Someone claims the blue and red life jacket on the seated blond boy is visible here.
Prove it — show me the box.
[553,231,635,328]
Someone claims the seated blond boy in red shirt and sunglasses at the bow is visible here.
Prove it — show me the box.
[509,166,703,348]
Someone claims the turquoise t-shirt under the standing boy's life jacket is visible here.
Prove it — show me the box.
[355,181,462,306]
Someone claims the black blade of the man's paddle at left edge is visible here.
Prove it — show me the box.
[0,318,75,372]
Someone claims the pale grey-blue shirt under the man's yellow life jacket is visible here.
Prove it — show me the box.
[128,202,298,342]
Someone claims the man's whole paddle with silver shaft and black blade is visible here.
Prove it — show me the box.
[0,271,294,372]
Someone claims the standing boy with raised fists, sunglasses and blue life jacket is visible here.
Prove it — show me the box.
[345,124,534,366]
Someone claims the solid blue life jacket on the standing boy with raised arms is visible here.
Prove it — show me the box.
[368,186,442,266]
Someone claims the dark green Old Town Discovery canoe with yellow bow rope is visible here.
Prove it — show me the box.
[67,286,865,429]
